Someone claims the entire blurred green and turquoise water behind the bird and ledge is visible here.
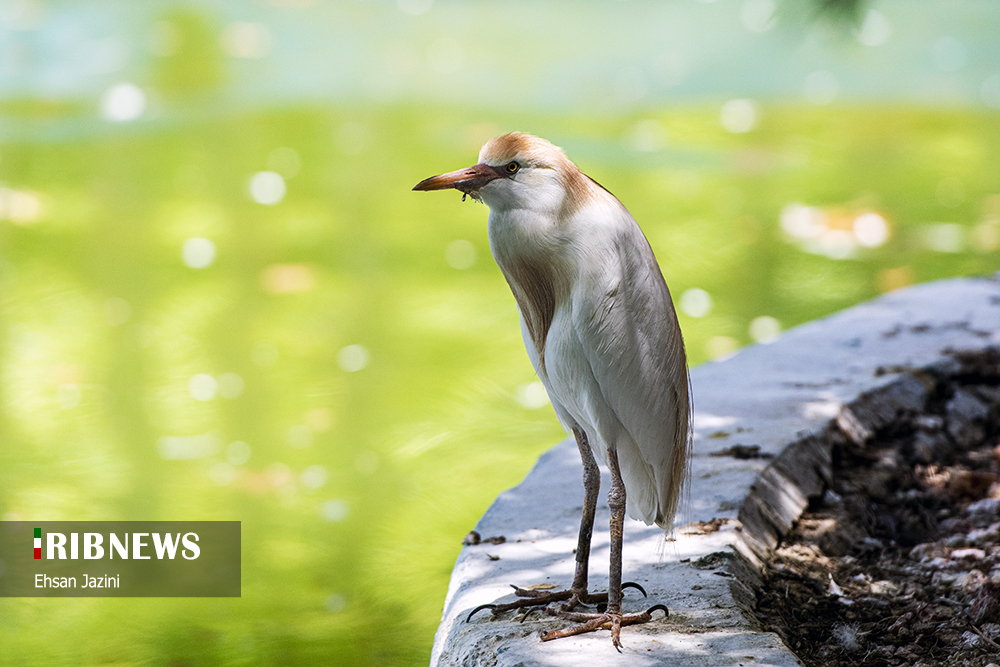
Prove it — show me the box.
[0,0,1000,666]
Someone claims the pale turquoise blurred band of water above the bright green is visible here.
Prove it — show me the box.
[0,0,1000,123]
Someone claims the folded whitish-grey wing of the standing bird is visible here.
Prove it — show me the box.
[573,207,689,528]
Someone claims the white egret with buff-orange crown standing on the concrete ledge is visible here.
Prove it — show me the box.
[413,132,690,648]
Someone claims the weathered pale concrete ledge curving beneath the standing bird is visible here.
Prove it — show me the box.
[431,278,1000,667]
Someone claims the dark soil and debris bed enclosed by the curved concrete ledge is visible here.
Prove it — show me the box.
[756,350,1000,667]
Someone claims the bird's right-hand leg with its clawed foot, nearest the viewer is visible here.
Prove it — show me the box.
[542,447,668,651]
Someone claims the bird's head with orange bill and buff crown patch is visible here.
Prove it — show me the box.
[413,132,587,218]
